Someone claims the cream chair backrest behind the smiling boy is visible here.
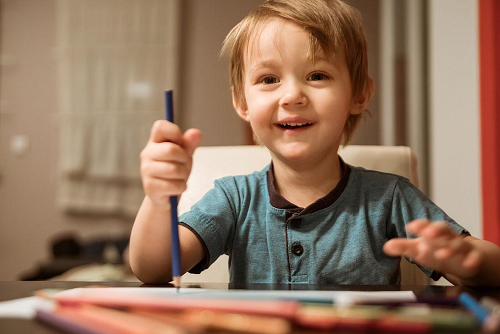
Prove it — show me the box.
[179,145,429,285]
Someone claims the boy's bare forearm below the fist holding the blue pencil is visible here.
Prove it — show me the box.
[130,196,172,283]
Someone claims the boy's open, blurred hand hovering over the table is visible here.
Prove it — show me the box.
[383,219,482,278]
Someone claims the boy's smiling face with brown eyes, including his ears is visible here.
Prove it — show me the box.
[235,19,365,162]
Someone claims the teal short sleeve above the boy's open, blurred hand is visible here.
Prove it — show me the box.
[387,178,470,280]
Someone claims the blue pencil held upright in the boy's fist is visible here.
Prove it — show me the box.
[165,90,181,289]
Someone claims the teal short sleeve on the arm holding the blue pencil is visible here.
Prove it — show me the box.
[179,180,236,273]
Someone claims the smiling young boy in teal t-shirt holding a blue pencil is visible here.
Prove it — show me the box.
[130,0,500,286]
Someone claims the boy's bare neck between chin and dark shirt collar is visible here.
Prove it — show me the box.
[273,154,342,208]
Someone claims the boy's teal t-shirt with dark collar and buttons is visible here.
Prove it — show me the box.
[179,164,468,285]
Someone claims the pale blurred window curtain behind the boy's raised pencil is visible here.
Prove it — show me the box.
[57,0,180,216]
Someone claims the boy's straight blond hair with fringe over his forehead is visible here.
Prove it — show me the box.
[221,0,370,143]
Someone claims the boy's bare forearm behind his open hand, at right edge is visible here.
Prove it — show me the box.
[445,237,500,287]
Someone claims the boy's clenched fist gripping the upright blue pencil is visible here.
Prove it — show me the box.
[140,120,202,206]
